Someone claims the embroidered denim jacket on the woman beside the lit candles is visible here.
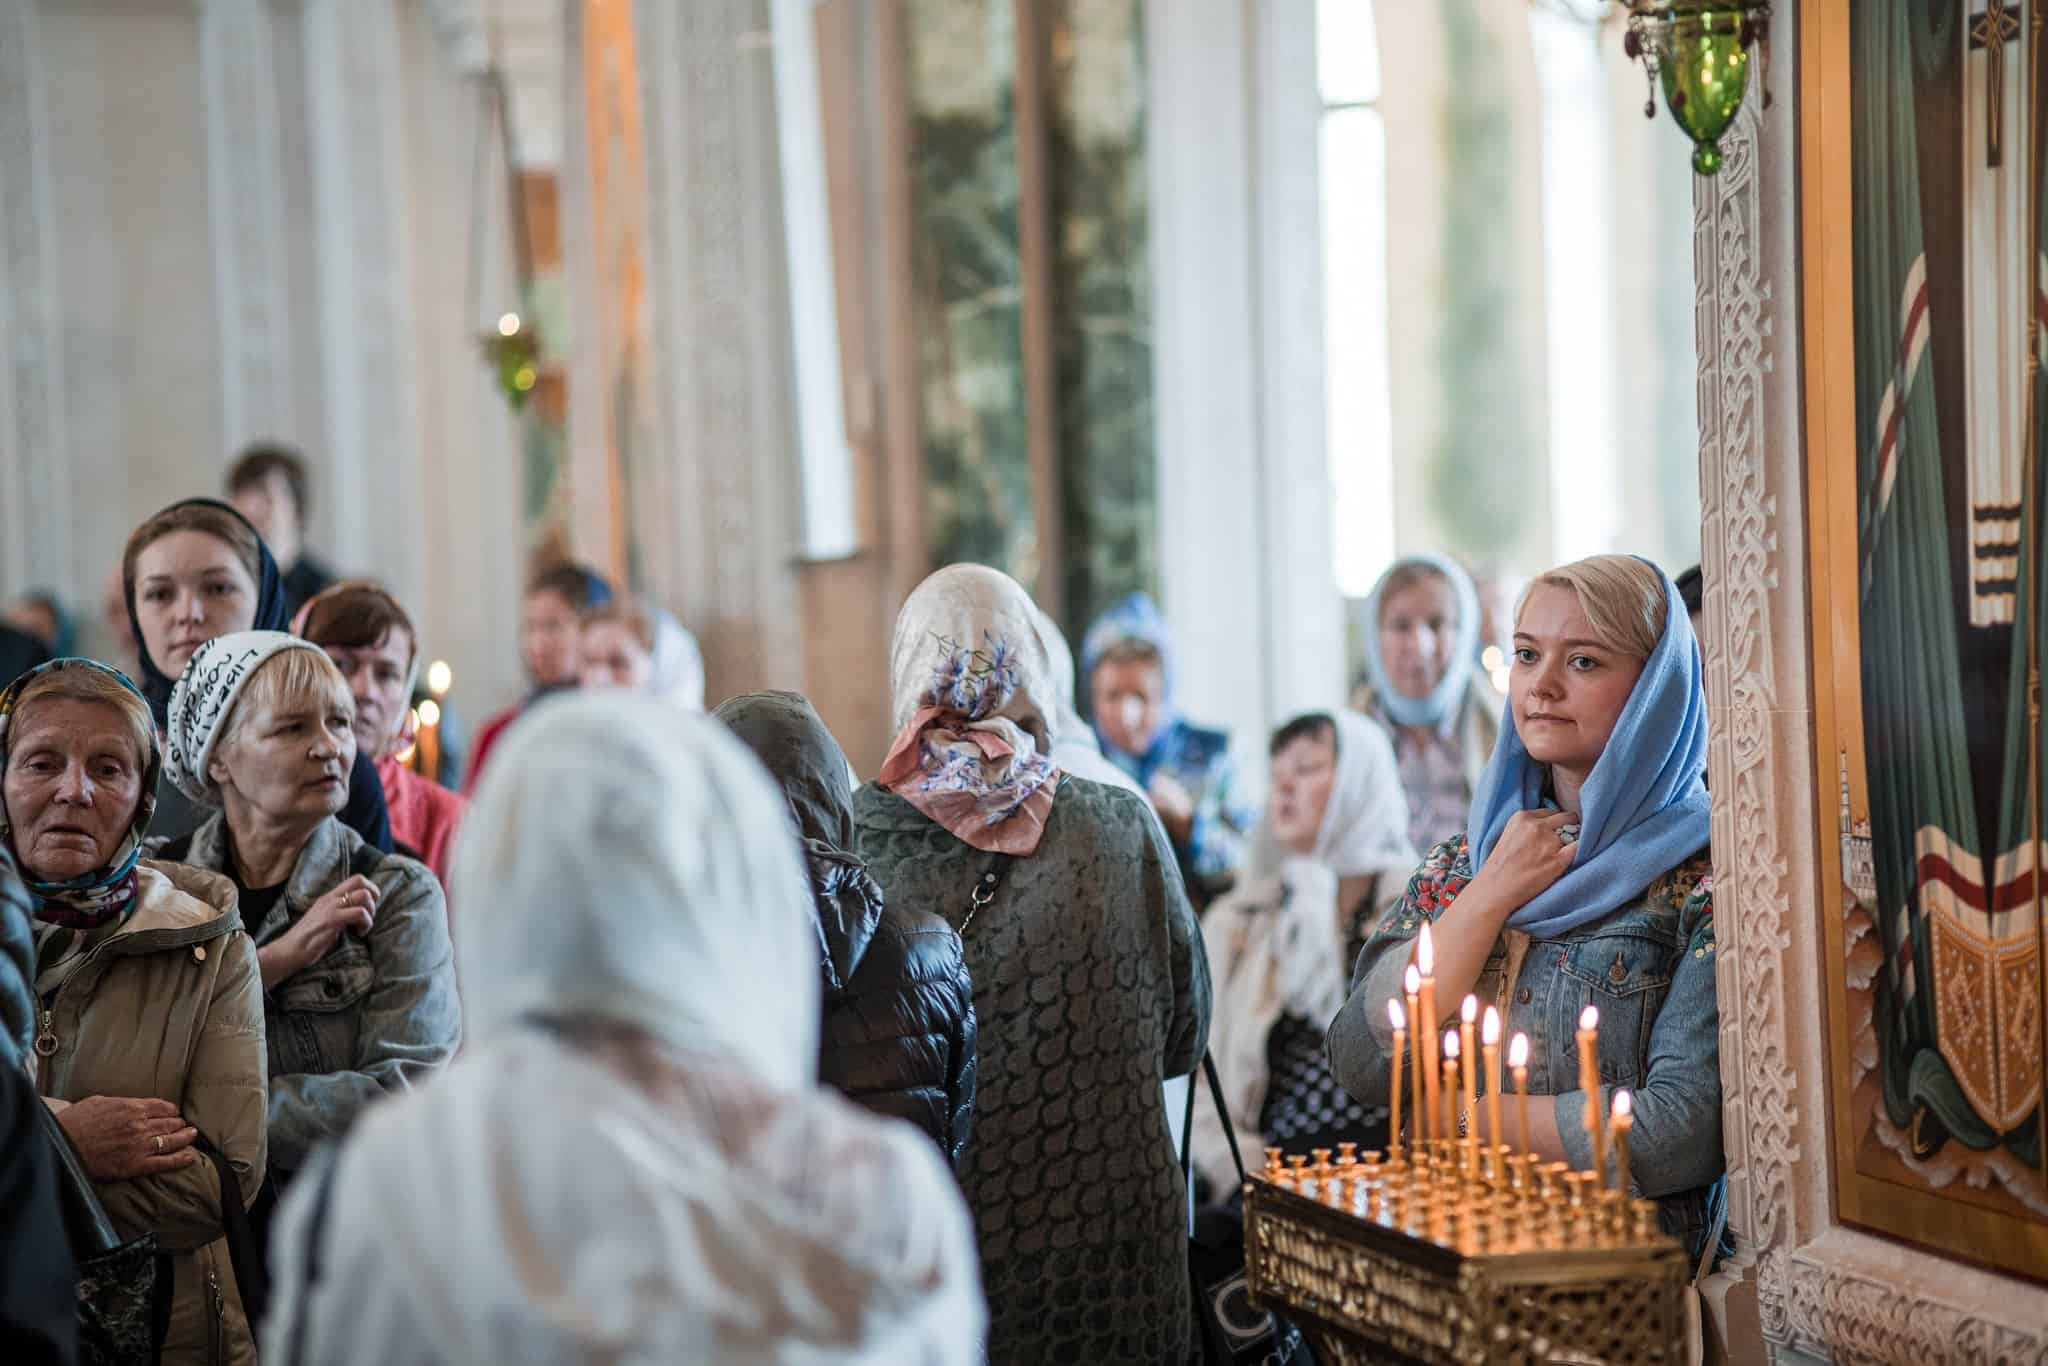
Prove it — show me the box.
[1327,836,1722,1257]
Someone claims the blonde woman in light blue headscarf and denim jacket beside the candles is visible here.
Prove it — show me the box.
[1327,555,1722,1257]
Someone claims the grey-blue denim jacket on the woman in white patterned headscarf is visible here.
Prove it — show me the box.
[154,813,463,1180]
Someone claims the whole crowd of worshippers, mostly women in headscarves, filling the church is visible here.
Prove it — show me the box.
[0,453,1724,1366]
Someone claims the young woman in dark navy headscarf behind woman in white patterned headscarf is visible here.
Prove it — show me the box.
[121,498,391,847]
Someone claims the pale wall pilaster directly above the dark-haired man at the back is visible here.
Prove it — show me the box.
[199,0,301,461]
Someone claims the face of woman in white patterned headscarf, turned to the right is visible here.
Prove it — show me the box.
[209,692,356,823]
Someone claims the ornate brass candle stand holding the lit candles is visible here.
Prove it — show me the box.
[1245,1139,1688,1366]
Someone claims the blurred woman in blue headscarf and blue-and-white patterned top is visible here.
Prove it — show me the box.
[1081,594,1257,909]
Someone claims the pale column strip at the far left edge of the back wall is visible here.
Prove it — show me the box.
[0,0,71,590]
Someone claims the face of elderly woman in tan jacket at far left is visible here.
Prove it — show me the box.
[0,698,143,883]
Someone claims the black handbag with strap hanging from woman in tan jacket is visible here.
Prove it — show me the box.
[35,1100,170,1366]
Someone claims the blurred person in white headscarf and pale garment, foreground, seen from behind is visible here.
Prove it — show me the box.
[264,694,985,1366]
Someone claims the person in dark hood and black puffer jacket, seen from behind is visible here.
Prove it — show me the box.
[713,692,975,1163]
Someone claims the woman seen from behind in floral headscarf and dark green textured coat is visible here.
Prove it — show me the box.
[854,565,1208,1366]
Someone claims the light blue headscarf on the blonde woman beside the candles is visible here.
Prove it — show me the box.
[1464,561,1708,938]
